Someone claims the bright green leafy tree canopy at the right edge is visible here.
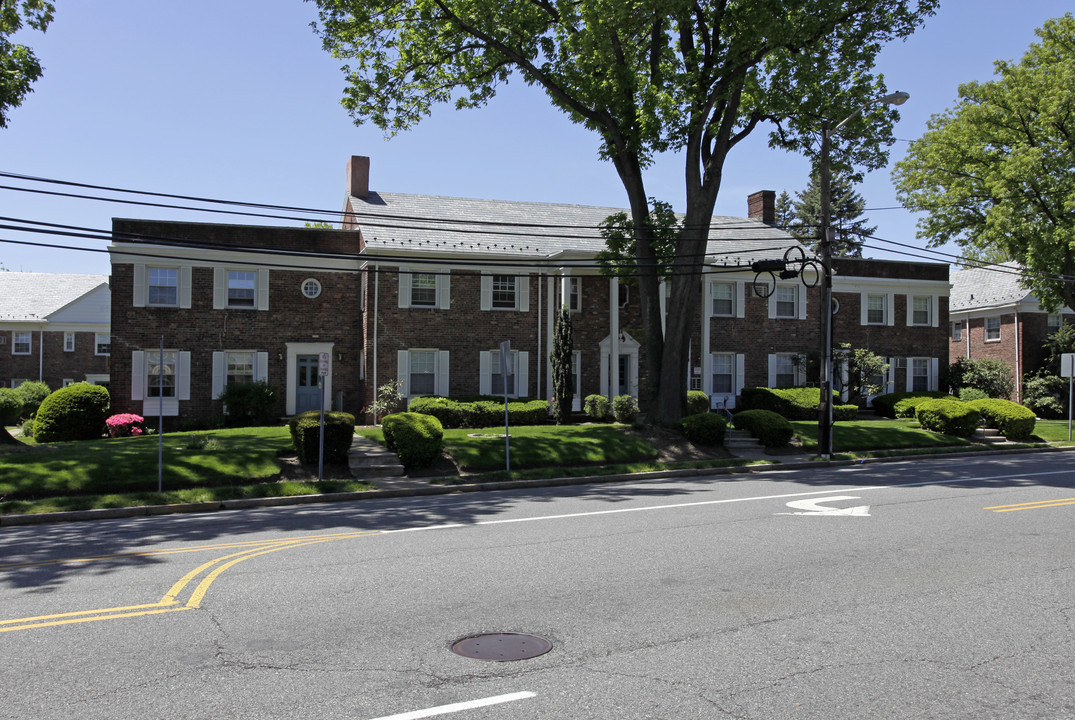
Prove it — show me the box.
[893,13,1075,309]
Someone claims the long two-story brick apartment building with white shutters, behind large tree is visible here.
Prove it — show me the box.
[110,157,948,425]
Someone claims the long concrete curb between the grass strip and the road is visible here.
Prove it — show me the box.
[0,446,1075,528]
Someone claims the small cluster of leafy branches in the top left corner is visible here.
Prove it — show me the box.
[0,0,54,128]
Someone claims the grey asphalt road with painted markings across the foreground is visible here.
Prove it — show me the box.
[0,452,1075,720]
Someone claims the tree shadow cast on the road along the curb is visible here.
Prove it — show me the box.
[0,455,1075,593]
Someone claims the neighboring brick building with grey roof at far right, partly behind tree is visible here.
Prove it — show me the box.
[948,262,1075,402]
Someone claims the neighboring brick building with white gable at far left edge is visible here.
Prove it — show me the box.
[0,272,111,390]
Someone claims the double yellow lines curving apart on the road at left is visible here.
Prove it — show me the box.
[0,531,383,633]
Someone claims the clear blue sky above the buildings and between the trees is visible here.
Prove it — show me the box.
[0,0,1070,274]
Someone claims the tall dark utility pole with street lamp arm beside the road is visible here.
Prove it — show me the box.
[817,92,911,460]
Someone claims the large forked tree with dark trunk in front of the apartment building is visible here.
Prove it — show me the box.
[314,0,938,424]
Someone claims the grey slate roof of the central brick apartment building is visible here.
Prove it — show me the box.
[347,192,799,264]
